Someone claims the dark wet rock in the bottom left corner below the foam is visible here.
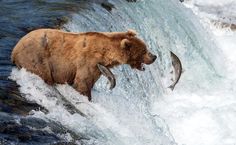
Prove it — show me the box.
[0,112,81,145]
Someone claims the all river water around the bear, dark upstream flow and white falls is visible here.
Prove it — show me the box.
[0,0,236,145]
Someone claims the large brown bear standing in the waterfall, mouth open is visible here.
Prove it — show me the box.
[11,29,156,100]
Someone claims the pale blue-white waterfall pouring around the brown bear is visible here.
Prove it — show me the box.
[11,0,234,145]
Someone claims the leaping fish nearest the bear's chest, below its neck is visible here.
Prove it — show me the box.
[97,64,116,90]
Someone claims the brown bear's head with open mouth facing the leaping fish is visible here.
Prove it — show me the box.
[120,30,157,71]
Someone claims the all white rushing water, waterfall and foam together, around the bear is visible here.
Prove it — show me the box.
[10,0,236,145]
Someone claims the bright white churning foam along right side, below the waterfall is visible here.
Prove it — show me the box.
[154,0,236,145]
